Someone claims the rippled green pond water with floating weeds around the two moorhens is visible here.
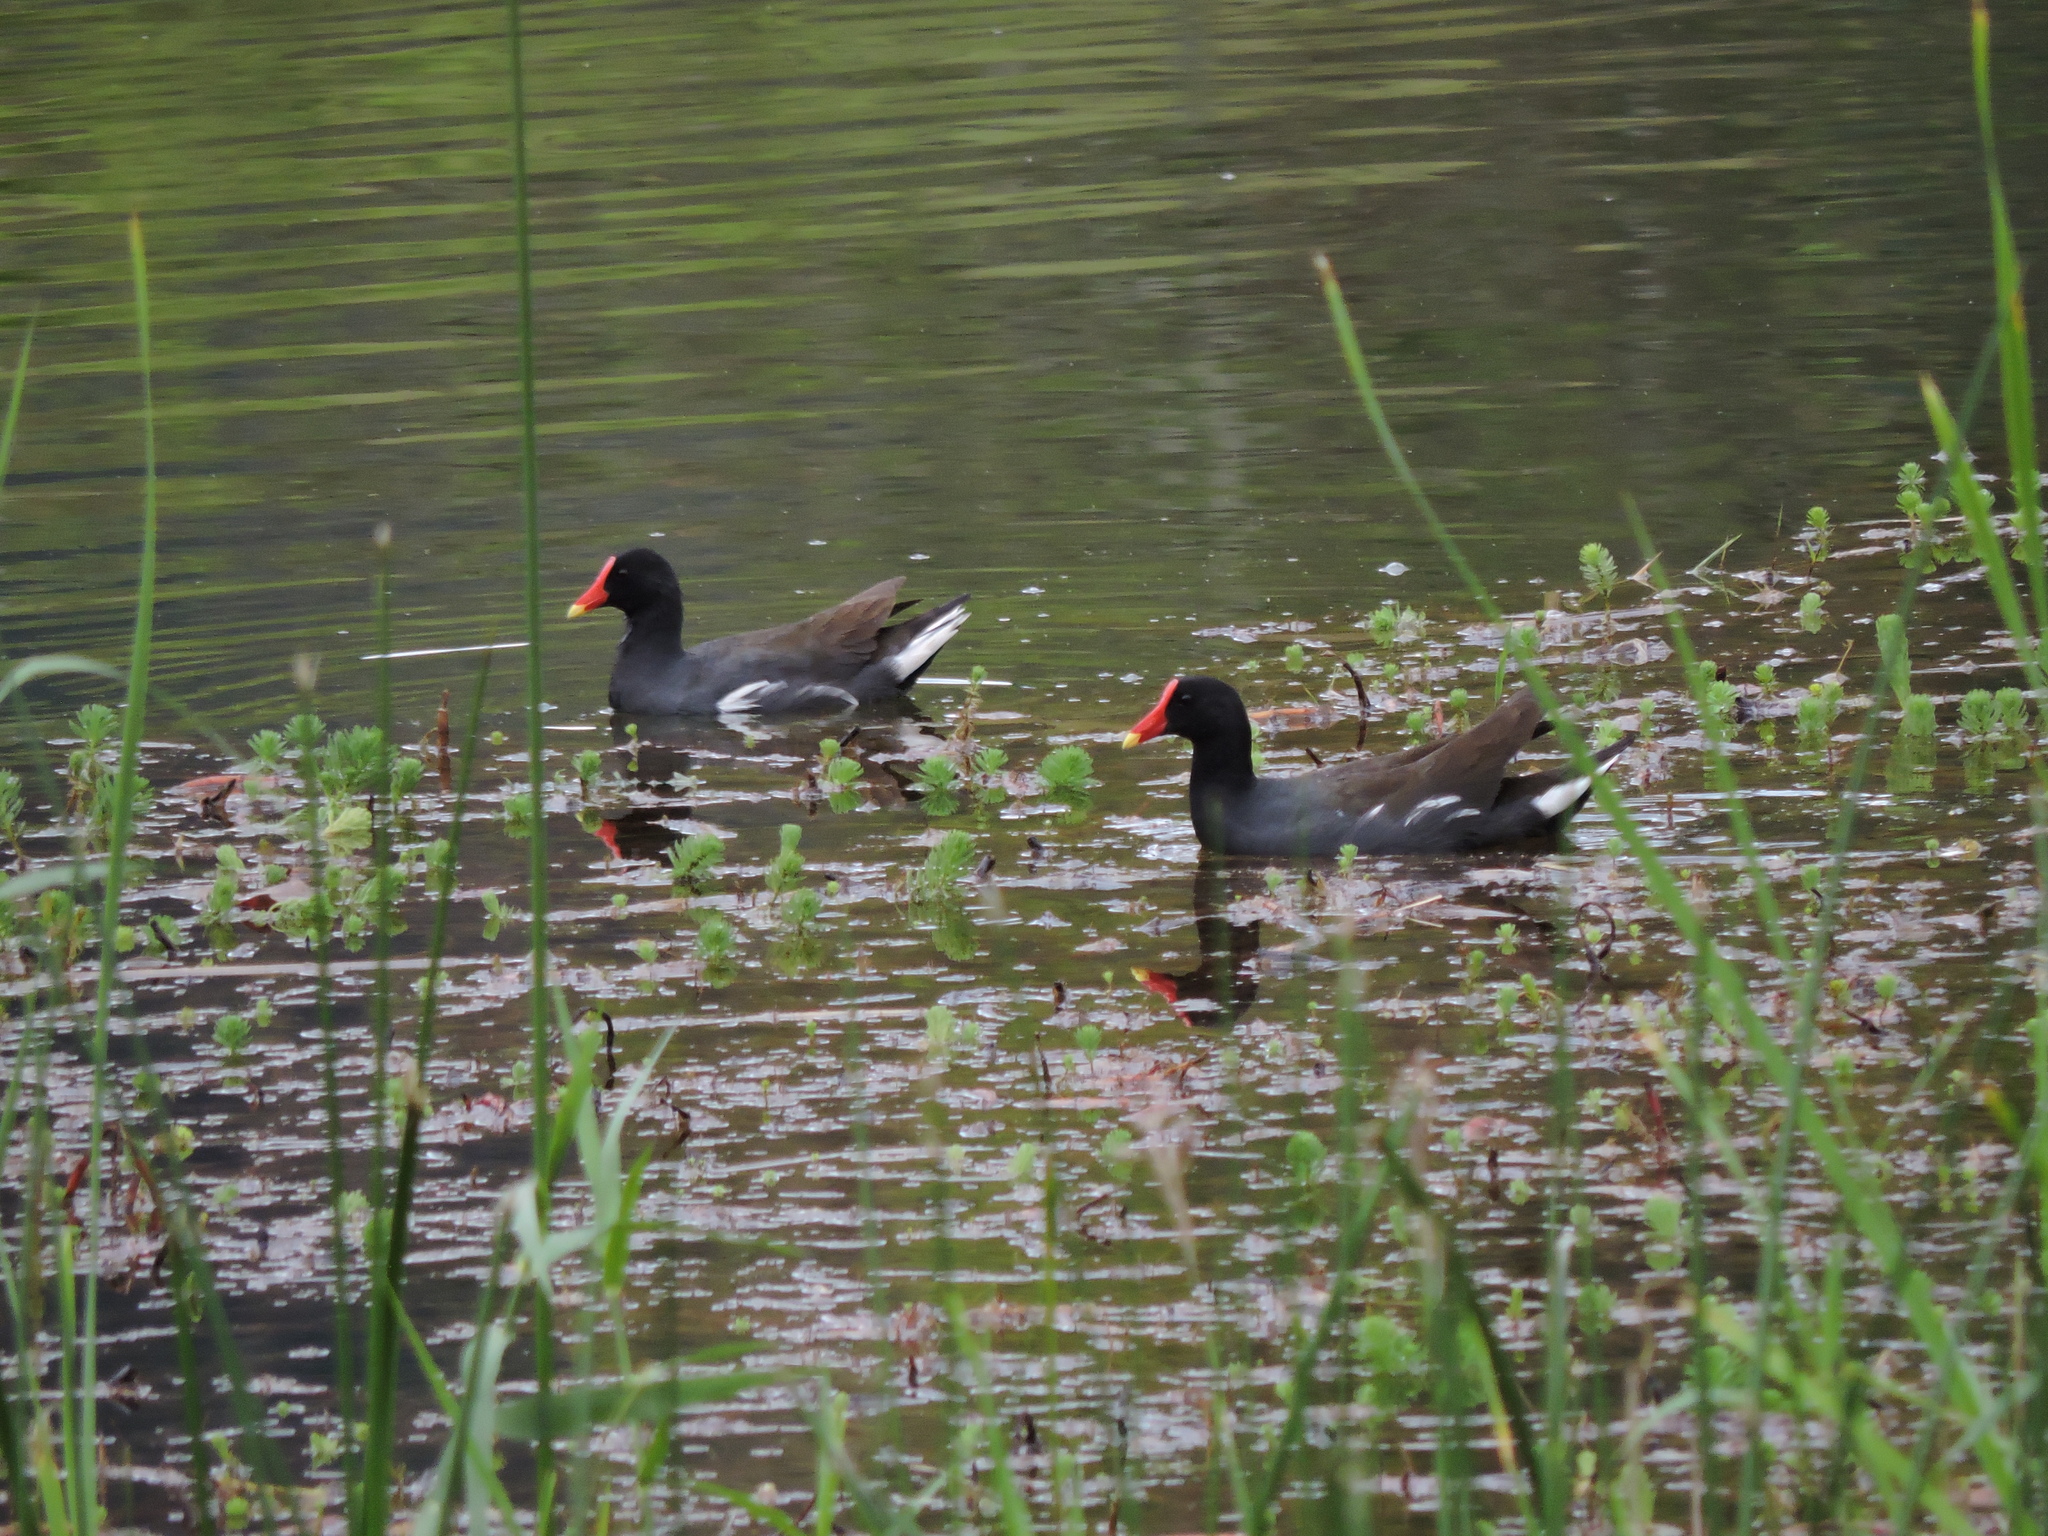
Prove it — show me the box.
[0,0,2048,1532]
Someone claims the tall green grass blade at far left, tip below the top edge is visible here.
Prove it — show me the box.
[72,215,156,1536]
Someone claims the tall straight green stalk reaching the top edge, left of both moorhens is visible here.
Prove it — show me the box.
[506,0,555,1536]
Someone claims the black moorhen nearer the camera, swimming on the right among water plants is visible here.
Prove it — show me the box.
[1124,678,1634,858]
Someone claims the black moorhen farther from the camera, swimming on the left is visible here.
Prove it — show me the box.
[569,549,967,715]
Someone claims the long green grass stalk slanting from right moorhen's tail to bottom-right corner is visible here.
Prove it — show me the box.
[1319,258,2038,1532]
